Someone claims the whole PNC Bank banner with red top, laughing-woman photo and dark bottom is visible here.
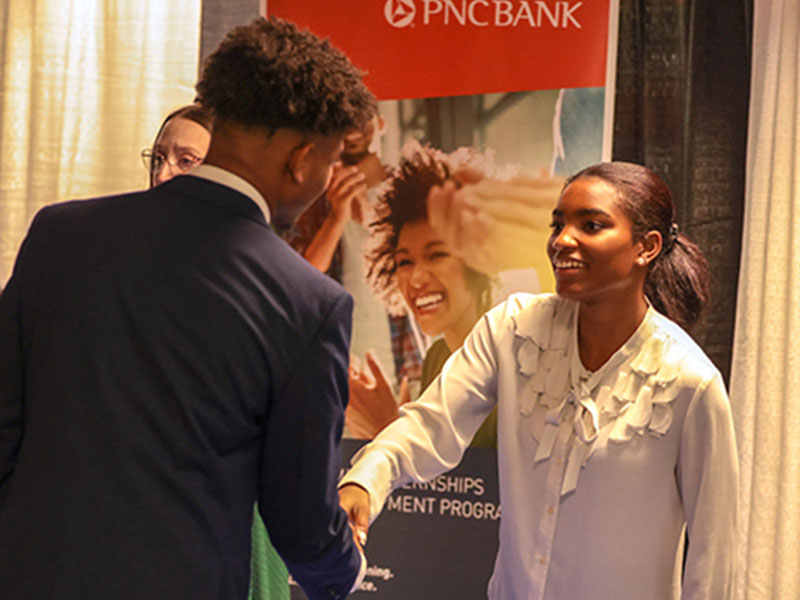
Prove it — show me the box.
[267,0,617,599]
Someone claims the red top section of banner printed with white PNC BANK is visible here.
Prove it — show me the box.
[267,0,612,100]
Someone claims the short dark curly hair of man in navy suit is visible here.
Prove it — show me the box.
[196,17,375,135]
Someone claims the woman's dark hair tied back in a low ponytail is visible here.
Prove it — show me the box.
[565,162,710,330]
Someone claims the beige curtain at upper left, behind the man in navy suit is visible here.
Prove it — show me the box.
[0,0,201,287]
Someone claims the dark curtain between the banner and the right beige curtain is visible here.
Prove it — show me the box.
[613,0,752,382]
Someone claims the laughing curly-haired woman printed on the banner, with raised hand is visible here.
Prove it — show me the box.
[346,144,497,448]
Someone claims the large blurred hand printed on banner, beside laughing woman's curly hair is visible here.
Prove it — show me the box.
[428,173,564,279]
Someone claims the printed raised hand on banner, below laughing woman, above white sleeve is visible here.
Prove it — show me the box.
[345,352,411,440]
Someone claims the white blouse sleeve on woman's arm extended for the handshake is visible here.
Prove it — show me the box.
[339,305,505,521]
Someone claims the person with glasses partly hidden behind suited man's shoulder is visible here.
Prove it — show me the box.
[142,104,212,187]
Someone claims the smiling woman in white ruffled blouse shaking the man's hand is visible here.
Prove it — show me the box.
[340,163,738,600]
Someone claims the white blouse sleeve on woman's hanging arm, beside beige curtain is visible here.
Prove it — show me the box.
[678,373,739,600]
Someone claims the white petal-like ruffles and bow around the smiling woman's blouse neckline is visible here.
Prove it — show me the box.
[512,296,686,493]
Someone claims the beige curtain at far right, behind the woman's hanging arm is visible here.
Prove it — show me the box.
[731,0,800,600]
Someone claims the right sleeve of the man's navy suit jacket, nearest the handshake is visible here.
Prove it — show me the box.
[259,294,362,600]
